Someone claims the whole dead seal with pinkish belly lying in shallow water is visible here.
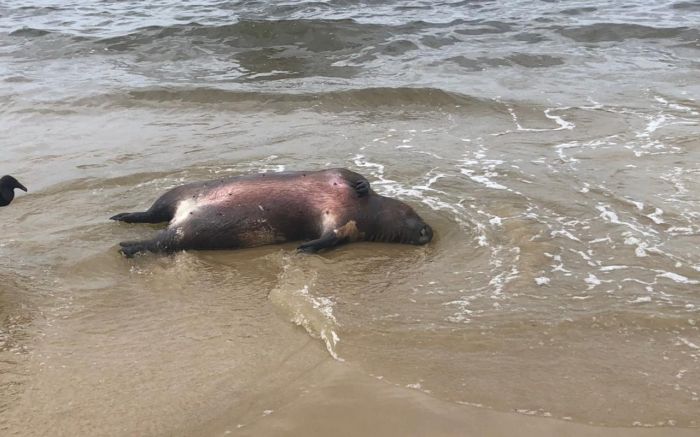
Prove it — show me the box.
[111,168,433,257]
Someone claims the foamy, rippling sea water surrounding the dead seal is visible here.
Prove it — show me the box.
[0,1,700,435]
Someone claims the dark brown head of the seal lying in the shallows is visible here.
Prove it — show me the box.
[366,195,433,245]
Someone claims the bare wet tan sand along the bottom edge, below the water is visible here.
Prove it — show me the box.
[205,361,698,437]
